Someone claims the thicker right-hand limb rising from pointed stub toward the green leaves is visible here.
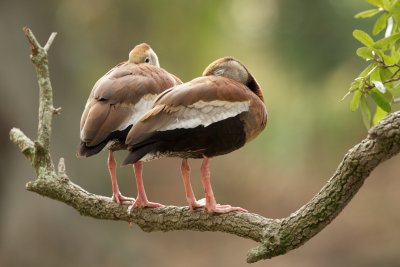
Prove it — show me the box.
[247,111,400,262]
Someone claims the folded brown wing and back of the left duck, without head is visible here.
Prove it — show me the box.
[78,63,180,156]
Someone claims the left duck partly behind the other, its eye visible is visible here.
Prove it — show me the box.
[77,43,182,207]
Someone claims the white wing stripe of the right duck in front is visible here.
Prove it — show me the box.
[158,100,250,131]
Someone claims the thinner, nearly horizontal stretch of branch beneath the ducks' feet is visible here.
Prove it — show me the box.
[27,170,271,242]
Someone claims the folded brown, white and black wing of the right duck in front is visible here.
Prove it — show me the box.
[124,76,263,164]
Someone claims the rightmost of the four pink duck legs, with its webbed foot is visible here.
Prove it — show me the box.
[201,158,247,213]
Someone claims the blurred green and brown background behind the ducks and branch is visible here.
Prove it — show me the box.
[0,0,400,267]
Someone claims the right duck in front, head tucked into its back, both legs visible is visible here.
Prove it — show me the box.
[123,57,267,213]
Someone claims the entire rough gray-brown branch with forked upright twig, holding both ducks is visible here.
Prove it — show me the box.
[10,28,400,263]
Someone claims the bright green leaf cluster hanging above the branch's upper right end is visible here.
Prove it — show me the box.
[346,0,400,128]
